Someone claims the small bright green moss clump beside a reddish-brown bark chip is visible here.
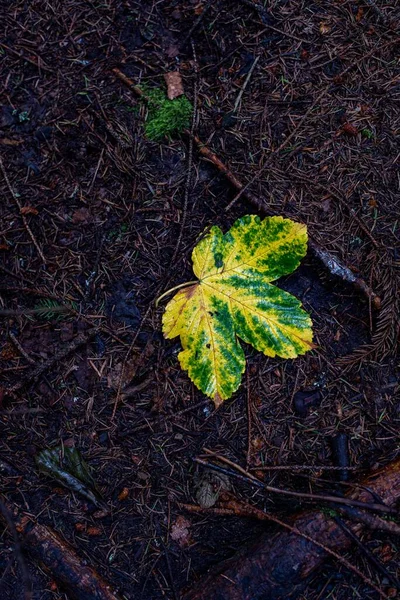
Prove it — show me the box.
[142,88,193,141]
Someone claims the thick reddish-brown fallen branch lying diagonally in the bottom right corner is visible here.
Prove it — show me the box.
[183,460,400,600]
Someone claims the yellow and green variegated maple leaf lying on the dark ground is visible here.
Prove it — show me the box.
[163,215,313,406]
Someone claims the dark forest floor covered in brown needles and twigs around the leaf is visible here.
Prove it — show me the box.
[0,0,400,600]
